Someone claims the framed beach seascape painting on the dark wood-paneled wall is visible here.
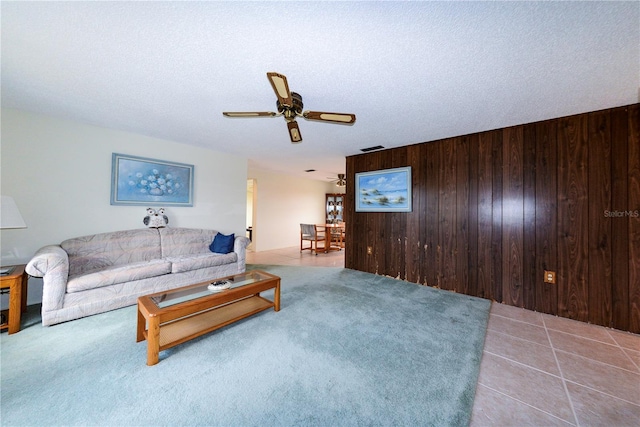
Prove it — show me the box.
[356,166,411,212]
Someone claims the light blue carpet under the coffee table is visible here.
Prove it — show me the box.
[0,266,490,426]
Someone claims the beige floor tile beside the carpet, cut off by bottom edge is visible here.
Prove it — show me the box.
[470,385,575,427]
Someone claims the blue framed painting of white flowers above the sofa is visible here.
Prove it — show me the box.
[111,153,193,206]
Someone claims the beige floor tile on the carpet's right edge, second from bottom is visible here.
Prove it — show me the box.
[478,353,574,422]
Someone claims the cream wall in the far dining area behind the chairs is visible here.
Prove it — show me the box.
[248,168,340,252]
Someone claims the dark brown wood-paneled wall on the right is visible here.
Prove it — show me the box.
[345,104,640,333]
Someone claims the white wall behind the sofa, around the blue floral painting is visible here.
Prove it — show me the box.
[0,109,247,304]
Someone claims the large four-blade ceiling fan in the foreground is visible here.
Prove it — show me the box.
[222,72,356,144]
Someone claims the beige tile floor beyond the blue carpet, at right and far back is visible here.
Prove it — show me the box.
[247,247,640,427]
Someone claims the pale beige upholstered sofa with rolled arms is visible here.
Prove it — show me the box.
[26,228,250,326]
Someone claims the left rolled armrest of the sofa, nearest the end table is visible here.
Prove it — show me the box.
[25,245,69,311]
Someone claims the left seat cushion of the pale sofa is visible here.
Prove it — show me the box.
[67,259,171,293]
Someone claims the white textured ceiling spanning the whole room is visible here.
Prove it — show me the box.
[1,1,640,180]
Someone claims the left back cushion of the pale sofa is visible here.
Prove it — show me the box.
[60,228,162,276]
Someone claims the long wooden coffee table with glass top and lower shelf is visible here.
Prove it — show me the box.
[136,270,280,366]
